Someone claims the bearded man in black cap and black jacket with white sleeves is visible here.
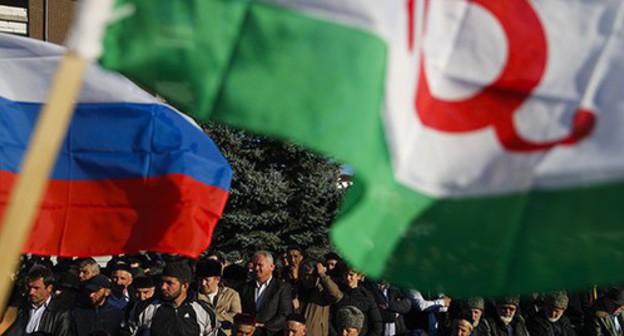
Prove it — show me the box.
[128,261,220,336]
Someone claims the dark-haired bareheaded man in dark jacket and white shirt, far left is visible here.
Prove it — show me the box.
[5,265,76,336]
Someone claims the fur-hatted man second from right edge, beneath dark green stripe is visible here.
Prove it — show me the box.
[527,292,576,336]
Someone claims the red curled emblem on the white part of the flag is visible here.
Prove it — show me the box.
[407,0,596,152]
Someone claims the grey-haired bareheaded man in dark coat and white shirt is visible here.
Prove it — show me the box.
[240,251,293,335]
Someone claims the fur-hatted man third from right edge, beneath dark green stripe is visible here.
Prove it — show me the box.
[488,297,529,336]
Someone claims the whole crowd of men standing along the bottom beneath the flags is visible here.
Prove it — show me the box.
[0,246,624,336]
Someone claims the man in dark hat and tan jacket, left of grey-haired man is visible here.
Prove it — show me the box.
[196,259,243,335]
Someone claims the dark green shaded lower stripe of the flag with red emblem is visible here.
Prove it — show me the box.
[386,183,624,296]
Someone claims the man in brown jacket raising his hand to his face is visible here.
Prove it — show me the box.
[299,259,342,336]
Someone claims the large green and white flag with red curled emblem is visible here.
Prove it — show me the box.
[96,0,624,295]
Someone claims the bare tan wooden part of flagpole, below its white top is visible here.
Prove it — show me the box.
[0,51,87,315]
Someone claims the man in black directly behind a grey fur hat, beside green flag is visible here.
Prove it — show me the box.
[329,262,383,336]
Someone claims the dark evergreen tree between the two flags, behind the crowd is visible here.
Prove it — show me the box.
[204,124,343,258]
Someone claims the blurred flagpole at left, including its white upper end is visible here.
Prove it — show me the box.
[0,0,114,316]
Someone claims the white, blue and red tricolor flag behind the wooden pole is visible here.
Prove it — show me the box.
[0,34,232,256]
